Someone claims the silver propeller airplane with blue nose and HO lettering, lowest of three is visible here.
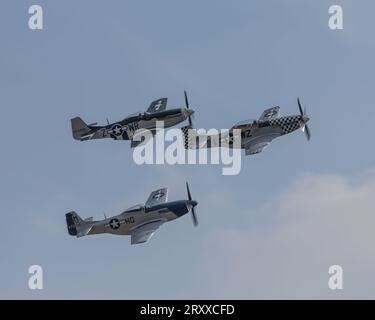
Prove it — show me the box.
[65,182,198,244]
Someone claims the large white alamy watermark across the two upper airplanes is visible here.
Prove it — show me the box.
[133,121,241,175]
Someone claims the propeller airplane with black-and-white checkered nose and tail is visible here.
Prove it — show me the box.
[181,98,311,156]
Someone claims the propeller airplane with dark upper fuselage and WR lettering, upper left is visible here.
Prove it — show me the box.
[70,91,194,148]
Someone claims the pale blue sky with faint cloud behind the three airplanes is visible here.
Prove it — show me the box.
[0,0,375,299]
